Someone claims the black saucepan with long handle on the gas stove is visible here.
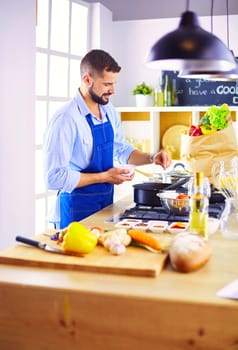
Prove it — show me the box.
[133,176,190,206]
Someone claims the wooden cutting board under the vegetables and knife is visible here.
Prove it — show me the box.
[0,235,171,277]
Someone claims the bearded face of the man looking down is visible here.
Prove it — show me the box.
[88,71,118,105]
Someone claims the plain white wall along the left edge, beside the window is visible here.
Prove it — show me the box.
[0,0,35,250]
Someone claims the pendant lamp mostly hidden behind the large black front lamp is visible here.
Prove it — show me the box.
[178,0,238,81]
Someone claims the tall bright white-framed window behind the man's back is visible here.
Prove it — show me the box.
[35,0,89,232]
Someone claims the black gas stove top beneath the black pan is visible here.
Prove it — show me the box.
[120,202,225,222]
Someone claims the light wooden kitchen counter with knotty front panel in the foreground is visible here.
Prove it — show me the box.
[0,196,238,350]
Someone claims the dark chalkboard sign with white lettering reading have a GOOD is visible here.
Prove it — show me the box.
[162,66,238,106]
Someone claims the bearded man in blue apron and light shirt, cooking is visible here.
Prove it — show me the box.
[44,50,171,228]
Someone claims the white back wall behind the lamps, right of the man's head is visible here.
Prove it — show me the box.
[112,15,238,106]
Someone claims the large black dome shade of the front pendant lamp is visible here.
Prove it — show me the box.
[146,11,236,72]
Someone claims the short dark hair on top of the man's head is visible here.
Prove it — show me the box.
[80,50,121,77]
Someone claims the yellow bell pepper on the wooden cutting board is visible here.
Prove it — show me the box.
[62,221,98,254]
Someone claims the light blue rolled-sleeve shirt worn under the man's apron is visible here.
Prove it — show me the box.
[43,92,135,193]
